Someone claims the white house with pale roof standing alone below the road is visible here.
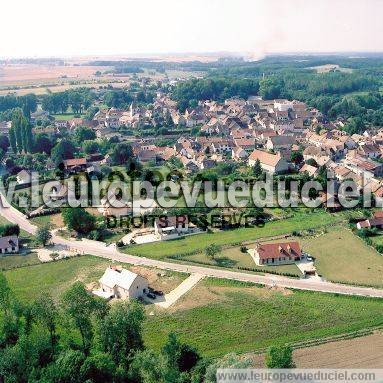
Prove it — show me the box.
[94,266,149,299]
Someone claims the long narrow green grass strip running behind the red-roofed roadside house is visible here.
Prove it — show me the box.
[123,210,344,259]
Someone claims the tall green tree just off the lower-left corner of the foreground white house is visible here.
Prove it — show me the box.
[61,282,101,355]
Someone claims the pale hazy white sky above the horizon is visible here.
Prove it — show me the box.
[0,0,383,57]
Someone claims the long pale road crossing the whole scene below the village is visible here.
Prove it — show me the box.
[0,198,383,298]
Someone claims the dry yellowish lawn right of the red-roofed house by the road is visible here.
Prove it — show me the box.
[302,226,383,287]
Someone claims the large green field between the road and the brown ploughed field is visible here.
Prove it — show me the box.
[144,279,383,356]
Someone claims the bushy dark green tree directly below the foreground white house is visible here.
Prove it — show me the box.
[99,301,145,366]
